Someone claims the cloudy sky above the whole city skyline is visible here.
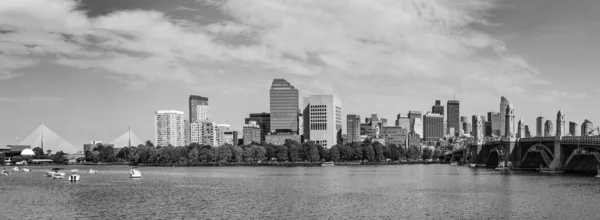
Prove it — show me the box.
[0,0,600,146]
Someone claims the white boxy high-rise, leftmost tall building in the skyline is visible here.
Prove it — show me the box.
[154,110,185,147]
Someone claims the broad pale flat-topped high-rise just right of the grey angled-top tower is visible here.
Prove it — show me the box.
[304,95,342,148]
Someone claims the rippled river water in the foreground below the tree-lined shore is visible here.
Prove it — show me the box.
[0,164,600,219]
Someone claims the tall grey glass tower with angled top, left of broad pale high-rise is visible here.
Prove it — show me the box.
[269,79,299,133]
